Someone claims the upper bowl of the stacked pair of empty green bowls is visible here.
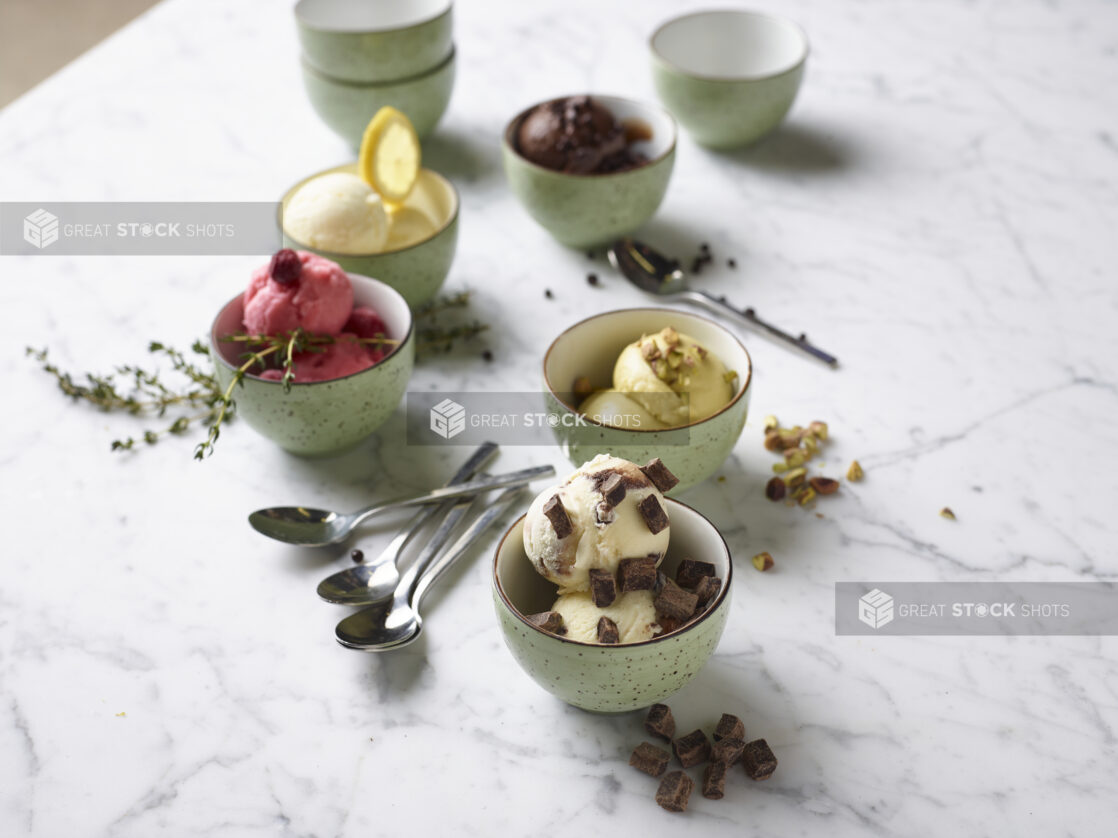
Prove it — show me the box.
[295,0,454,82]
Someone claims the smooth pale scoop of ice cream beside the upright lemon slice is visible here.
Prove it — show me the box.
[283,172,388,254]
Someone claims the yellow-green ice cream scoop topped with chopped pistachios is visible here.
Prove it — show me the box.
[614,326,733,427]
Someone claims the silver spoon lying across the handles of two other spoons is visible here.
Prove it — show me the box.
[248,466,556,547]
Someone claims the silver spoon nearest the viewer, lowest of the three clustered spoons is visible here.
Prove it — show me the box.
[334,486,523,651]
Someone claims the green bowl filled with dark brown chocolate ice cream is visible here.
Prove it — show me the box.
[501,95,676,248]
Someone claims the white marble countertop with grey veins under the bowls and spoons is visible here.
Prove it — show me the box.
[0,0,1118,837]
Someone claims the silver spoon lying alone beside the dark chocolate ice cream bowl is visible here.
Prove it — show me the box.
[608,238,839,368]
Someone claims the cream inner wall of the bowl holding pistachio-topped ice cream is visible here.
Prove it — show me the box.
[543,308,751,408]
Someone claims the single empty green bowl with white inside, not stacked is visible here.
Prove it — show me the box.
[650,10,807,149]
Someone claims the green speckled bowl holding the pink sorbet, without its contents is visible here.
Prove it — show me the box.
[210,274,415,456]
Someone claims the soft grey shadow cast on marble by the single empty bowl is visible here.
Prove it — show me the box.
[707,122,858,174]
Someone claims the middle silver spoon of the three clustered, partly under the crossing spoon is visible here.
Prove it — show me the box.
[319,489,474,606]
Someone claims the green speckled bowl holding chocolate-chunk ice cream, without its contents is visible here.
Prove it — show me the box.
[493,498,733,713]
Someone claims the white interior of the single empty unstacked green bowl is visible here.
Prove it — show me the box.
[652,11,807,79]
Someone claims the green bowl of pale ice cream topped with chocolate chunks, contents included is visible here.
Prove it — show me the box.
[492,456,733,713]
